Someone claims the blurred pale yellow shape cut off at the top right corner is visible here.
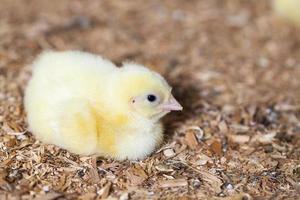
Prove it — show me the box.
[273,0,300,26]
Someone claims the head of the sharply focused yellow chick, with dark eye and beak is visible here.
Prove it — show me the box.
[111,64,182,120]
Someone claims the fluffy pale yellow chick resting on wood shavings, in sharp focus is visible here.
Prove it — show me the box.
[24,51,182,160]
